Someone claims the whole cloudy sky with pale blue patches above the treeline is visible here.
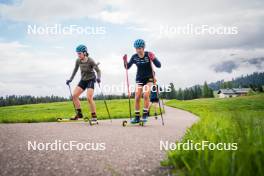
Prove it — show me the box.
[0,0,264,96]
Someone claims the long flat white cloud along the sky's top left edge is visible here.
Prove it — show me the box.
[0,0,104,23]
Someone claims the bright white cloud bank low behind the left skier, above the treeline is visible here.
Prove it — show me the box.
[0,41,135,96]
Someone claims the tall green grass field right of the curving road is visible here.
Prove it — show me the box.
[162,94,264,176]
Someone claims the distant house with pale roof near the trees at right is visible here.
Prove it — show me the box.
[217,88,250,98]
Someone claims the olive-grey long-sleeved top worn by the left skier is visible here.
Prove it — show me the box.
[70,57,101,80]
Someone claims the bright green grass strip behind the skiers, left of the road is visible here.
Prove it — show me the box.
[0,99,161,123]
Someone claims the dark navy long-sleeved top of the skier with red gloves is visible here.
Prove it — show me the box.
[127,51,161,80]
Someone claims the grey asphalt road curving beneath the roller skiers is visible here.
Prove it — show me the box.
[0,107,197,176]
